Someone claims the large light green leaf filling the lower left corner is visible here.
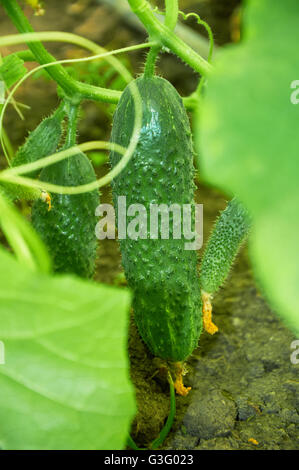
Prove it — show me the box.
[0,249,135,449]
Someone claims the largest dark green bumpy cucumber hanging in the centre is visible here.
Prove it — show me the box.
[110,77,202,361]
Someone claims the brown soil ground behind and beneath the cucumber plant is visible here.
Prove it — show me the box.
[0,0,299,450]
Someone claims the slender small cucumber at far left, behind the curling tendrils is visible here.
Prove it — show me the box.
[11,111,62,178]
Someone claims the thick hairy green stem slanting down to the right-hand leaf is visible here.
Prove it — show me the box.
[128,0,212,76]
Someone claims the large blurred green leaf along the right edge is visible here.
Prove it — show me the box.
[195,0,299,334]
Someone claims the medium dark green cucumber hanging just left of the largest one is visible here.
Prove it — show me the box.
[32,153,100,278]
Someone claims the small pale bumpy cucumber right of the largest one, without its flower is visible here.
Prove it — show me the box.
[200,198,250,294]
